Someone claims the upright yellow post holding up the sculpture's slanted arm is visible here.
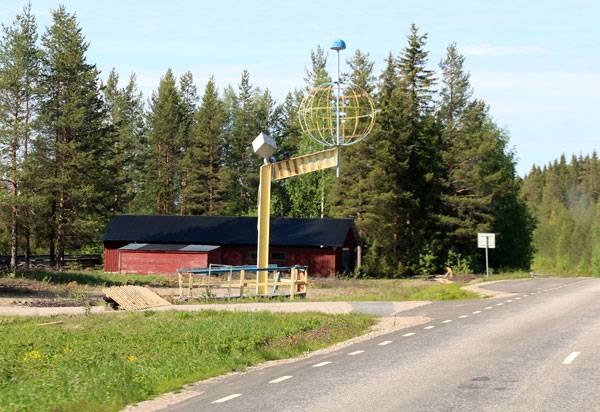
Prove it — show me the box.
[256,163,272,295]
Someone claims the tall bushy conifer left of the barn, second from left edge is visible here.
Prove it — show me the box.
[36,6,113,268]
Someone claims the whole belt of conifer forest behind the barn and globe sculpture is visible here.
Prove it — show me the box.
[0,6,544,276]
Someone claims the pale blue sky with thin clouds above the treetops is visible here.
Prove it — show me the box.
[0,0,600,175]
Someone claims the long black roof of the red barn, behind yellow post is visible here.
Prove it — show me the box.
[101,215,353,247]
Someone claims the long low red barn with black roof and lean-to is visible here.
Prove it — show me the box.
[102,215,357,276]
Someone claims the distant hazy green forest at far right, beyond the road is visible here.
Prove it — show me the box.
[523,152,600,275]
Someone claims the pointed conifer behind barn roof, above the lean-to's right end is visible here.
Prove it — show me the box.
[188,77,225,215]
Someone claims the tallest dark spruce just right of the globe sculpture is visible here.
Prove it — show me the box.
[365,25,443,274]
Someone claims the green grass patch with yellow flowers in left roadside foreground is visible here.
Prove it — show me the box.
[0,311,374,411]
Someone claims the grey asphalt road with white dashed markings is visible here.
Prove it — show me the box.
[168,279,600,412]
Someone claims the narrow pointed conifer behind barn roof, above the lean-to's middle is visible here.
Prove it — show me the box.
[145,69,182,214]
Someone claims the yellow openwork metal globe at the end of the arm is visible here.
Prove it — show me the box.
[298,83,375,147]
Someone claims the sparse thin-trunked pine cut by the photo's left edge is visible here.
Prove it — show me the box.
[0,4,39,271]
